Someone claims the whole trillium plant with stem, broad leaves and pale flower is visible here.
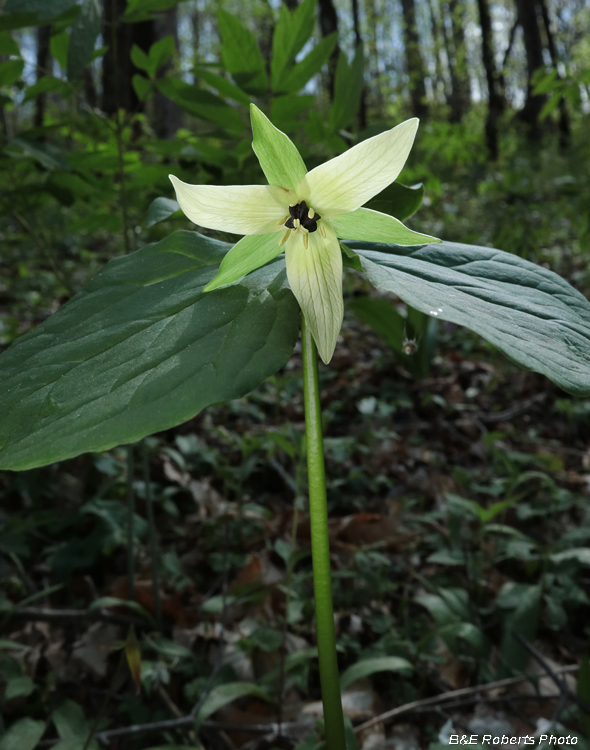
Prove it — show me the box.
[0,106,590,750]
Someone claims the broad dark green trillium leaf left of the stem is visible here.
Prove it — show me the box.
[0,232,298,469]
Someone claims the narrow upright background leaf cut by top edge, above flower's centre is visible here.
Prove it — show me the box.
[270,0,316,91]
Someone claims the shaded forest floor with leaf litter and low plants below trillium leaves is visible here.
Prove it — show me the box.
[0,302,590,750]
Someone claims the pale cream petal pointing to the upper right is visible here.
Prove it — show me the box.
[297,117,418,218]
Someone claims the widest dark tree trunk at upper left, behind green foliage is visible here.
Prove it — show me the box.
[102,0,156,115]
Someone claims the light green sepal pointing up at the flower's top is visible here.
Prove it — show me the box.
[250,104,307,192]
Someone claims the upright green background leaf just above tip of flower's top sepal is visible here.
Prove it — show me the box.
[217,8,268,94]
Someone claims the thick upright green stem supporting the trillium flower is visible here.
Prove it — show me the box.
[301,316,346,750]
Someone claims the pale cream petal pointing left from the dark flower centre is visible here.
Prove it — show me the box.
[169,175,295,234]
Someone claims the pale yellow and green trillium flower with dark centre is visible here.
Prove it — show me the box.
[170,104,438,363]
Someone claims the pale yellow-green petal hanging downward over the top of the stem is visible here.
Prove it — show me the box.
[285,222,344,364]
